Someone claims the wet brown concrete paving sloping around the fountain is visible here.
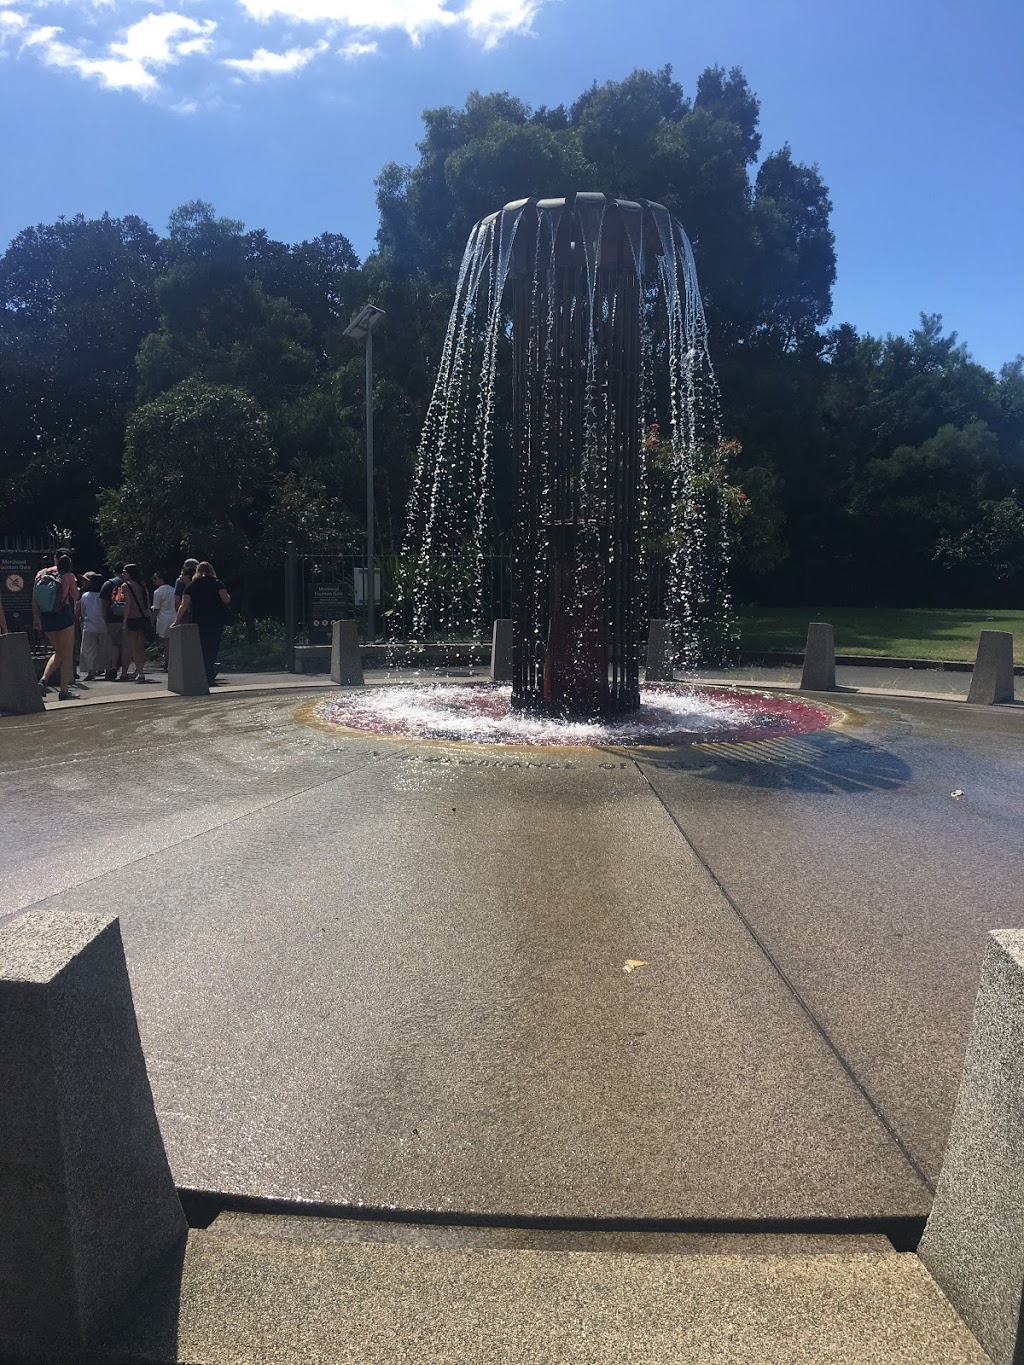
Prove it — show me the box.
[0,693,1024,1220]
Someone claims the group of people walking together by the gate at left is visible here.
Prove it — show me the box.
[0,550,231,702]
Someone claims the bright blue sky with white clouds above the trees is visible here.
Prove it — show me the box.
[0,0,1024,369]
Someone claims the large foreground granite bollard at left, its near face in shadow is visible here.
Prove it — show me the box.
[0,910,188,1360]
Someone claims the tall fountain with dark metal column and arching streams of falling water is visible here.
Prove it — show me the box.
[406,194,729,715]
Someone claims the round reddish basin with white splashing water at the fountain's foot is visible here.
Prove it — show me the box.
[314,683,834,745]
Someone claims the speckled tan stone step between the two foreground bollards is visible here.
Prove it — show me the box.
[98,1215,987,1365]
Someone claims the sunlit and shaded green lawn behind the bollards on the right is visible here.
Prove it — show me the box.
[739,606,1024,663]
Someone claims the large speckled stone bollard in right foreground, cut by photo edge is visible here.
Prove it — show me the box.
[918,930,1024,1365]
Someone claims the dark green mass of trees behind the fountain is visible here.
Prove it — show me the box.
[0,66,1024,605]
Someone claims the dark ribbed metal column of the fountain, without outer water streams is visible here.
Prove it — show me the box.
[494,194,672,714]
